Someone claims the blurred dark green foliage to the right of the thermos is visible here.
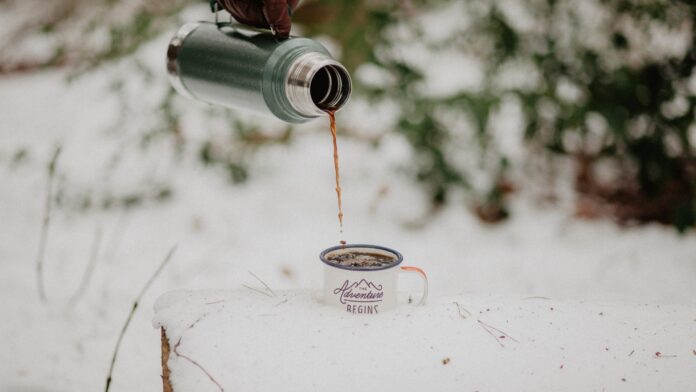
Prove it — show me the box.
[298,0,696,229]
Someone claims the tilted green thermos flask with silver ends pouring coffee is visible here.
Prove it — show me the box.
[167,22,351,123]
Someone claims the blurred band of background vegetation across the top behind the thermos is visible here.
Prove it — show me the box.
[0,0,696,231]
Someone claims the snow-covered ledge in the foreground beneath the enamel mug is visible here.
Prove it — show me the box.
[154,290,696,392]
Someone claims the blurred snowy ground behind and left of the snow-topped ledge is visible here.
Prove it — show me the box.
[0,15,696,392]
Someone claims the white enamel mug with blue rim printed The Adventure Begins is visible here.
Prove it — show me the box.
[319,244,428,314]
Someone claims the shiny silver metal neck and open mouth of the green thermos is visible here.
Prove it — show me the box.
[285,52,351,117]
